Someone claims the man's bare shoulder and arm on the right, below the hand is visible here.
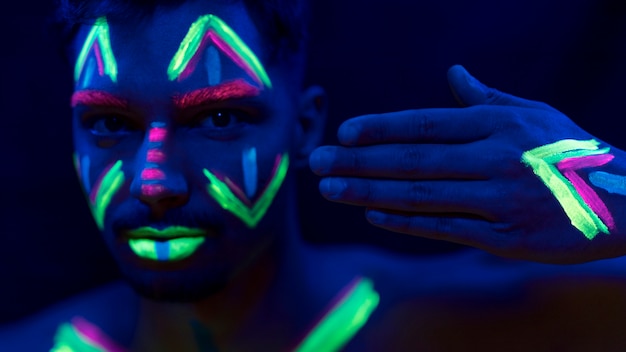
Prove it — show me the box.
[316,249,626,351]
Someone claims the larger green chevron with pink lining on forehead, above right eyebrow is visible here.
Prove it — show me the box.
[167,14,272,88]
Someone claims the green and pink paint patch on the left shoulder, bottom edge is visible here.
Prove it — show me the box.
[51,317,125,352]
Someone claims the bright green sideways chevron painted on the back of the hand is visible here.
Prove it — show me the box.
[522,139,609,240]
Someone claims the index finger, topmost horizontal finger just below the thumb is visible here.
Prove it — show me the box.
[337,107,498,146]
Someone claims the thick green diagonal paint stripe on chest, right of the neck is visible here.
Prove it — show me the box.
[295,278,380,352]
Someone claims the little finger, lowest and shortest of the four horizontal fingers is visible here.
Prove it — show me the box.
[365,209,494,250]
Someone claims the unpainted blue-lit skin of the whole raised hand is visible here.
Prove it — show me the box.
[310,66,626,263]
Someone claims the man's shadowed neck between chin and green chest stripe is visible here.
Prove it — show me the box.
[127,205,326,352]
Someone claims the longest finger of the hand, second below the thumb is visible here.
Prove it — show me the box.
[309,142,498,180]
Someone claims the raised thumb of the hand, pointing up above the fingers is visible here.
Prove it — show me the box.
[448,65,556,111]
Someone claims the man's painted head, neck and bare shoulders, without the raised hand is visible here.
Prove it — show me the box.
[0,0,626,351]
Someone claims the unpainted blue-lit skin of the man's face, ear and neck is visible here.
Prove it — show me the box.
[73,2,336,351]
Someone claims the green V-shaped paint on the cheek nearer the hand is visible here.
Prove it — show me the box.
[203,152,289,228]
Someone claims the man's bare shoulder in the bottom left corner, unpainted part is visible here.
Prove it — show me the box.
[0,282,137,351]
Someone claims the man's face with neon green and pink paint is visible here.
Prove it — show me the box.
[72,1,297,300]
